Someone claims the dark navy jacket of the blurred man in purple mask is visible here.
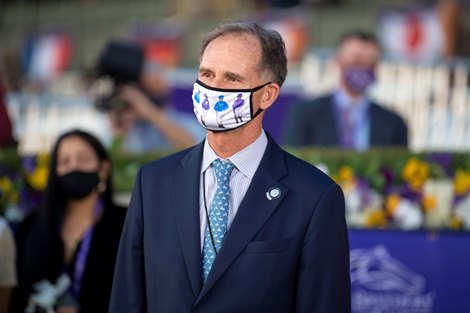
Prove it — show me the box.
[283,95,408,147]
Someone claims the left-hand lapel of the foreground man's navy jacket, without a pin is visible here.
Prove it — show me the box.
[169,141,204,299]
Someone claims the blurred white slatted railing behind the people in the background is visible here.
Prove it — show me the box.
[7,60,470,154]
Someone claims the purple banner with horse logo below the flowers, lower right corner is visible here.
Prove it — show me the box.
[349,230,470,313]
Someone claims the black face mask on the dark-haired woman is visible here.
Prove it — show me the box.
[59,171,100,200]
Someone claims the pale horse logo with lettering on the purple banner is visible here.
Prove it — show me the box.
[350,245,435,313]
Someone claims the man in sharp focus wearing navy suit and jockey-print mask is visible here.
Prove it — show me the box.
[110,22,350,313]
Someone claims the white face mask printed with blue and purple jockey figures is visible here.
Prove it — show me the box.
[193,80,270,131]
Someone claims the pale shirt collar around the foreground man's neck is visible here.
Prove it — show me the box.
[201,130,268,179]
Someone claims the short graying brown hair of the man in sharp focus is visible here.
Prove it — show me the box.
[201,21,287,86]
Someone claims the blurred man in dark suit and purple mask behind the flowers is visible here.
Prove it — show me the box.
[284,31,408,150]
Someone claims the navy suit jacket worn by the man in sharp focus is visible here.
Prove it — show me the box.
[110,138,350,313]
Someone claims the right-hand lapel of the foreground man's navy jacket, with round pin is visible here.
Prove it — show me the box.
[196,137,287,304]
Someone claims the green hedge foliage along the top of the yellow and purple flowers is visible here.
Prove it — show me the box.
[0,147,470,192]
